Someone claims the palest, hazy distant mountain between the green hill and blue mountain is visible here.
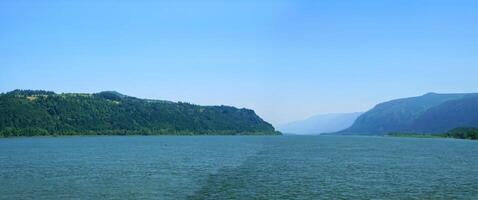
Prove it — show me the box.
[277,112,362,135]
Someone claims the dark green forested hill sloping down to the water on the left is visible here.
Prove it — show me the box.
[0,90,280,136]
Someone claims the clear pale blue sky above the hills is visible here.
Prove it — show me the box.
[0,0,478,124]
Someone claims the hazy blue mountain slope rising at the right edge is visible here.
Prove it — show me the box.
[338,93,478,135]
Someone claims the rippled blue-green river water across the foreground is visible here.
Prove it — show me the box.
[0,136,478,199]
